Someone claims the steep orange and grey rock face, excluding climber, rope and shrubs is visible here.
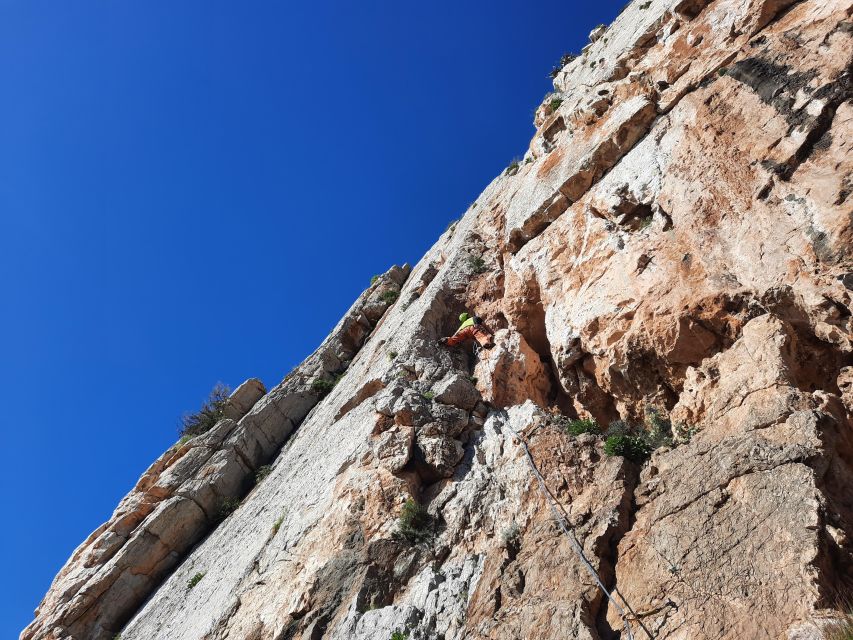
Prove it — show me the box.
[21,0,853,640]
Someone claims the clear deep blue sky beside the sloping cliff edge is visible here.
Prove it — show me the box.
[0,0,624,638]
